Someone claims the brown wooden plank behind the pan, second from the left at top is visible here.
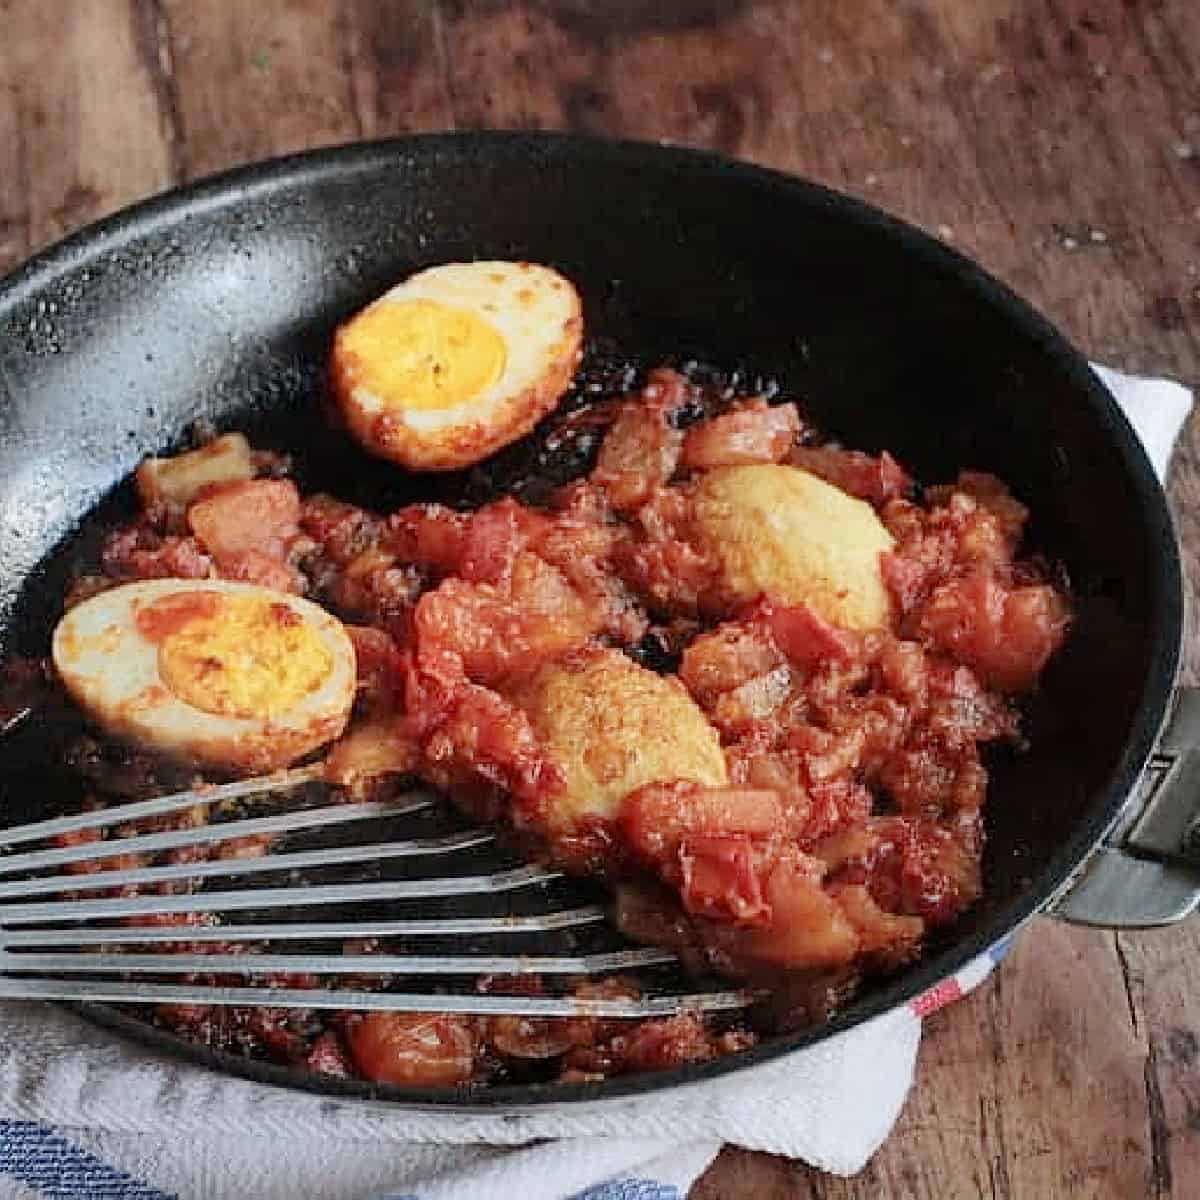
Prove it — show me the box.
[161,0,359,178]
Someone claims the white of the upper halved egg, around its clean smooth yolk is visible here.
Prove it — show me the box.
[332,262,583,469]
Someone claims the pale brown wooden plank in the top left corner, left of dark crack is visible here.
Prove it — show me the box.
[0,0,172,270]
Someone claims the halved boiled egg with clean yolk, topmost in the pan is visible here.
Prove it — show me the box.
[330,262,583,470]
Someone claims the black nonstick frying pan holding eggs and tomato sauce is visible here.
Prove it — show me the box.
[0,133,1182,1108]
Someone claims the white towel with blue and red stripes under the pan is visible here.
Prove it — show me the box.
[0,367,1192,1200]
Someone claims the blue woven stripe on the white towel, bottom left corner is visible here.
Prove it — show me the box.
[0,1121,179,1200]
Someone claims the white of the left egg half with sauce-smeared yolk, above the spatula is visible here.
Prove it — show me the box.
[52,580,356,773]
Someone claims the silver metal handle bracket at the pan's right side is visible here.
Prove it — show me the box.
[1045,688,1200,929]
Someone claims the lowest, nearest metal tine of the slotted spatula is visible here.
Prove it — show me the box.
[0,976,756,1019]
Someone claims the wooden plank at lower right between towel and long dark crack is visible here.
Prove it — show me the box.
[692,920,1152,1200]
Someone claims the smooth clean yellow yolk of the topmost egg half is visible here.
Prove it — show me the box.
[341,300,506,409]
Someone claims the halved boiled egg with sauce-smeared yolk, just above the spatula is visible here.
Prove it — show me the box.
[52,580,355,773]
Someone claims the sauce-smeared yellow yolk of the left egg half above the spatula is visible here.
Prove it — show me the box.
[158,593,334,718]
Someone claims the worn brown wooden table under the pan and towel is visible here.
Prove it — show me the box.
[0,0,1200,1200]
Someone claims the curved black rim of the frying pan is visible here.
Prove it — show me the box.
[0,131,1183,1114]
